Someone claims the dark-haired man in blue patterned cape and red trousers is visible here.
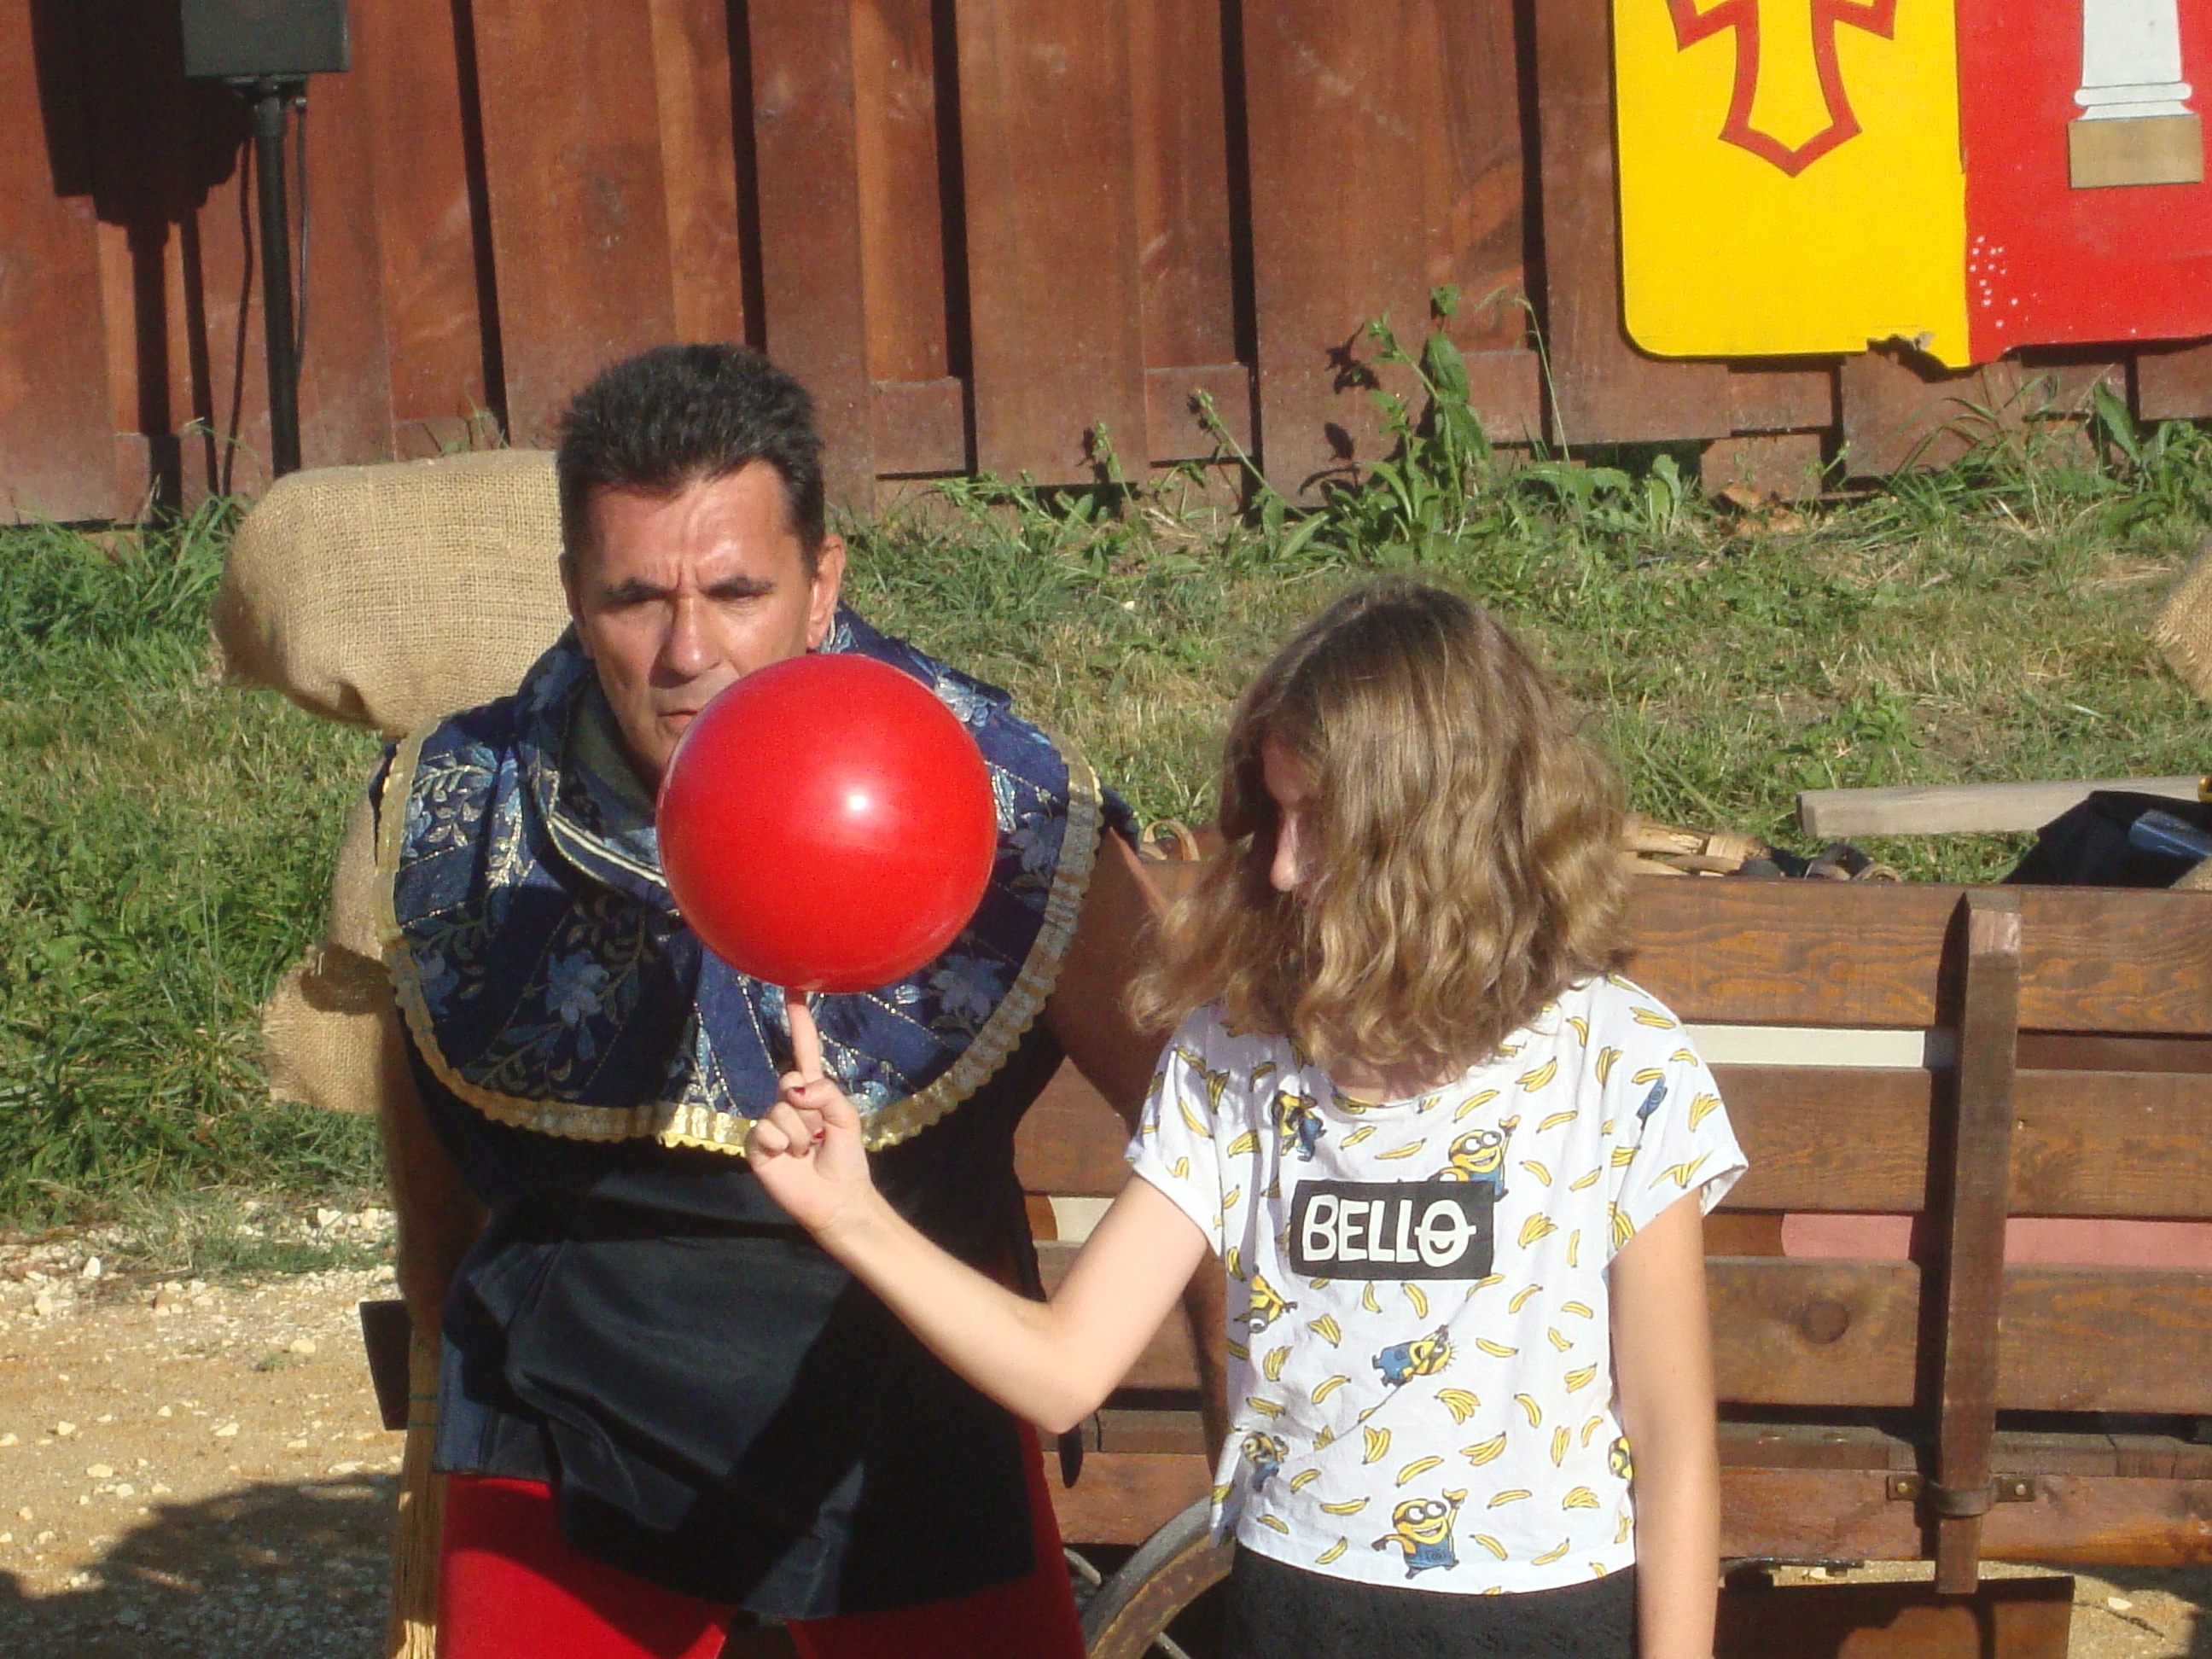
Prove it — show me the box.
[374,345,1159,1659]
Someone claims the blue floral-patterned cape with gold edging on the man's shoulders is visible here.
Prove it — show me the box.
[376,610,1126,1152]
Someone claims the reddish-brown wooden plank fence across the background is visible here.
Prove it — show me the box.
[0,0,2212,520]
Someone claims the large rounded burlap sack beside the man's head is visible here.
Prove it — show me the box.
[214,449,568,736]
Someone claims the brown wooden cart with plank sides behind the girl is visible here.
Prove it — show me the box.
[1020,871,2212,1655]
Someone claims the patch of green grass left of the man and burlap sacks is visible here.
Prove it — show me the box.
[0,511,376,1225]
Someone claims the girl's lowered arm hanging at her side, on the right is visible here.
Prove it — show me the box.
[1610,1195,1721,1659]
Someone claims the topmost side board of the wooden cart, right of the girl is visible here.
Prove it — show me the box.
[1630,881,2212,1035]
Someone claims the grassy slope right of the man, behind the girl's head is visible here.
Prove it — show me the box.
[849,336,2212,881]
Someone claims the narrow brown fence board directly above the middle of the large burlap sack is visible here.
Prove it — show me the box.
[350,0,498,456]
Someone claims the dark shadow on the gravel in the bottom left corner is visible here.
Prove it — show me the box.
[0,1476,396,1659]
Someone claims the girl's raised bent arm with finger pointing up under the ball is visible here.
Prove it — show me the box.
[746,1062,1208,1434]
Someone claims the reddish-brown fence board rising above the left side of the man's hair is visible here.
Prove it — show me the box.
[474,0,675,445]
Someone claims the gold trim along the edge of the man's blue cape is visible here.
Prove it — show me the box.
[376,728,1102,1157]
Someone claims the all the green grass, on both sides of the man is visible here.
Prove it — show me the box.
[0,336,2212,1230]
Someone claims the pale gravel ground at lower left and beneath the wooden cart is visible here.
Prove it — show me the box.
[0,1210,2212,1659]
